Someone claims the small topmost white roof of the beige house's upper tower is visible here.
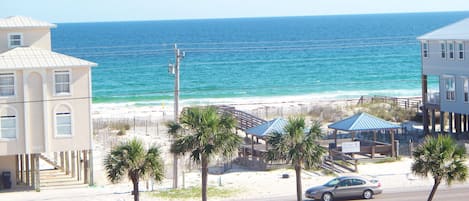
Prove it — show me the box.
[0,16,57,29]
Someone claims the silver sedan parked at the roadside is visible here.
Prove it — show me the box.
[305,176,383,201]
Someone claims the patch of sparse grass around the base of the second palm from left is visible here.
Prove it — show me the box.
[149,186,241,200]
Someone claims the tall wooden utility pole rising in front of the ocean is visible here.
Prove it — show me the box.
[168,44,184,188]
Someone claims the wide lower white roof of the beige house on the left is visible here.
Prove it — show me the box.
[0,47,97,70]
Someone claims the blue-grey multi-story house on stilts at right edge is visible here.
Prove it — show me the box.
[418,18,469,133]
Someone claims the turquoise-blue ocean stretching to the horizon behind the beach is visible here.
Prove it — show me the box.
[52,12,469,105]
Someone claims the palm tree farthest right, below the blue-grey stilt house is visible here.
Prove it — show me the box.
[411,135,467,201]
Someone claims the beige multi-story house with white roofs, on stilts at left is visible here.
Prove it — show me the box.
[0,16,96,189]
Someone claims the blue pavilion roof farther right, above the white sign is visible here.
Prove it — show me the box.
[328,112,400,131]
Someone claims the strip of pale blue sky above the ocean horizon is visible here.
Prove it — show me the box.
[0,0,469,22]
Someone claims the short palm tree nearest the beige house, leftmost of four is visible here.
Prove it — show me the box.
[104,138,164,201]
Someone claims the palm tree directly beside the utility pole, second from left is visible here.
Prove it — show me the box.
[171,107,241,201]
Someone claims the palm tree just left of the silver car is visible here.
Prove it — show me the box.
[267,117,325,201]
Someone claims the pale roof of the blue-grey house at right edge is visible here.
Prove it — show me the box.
[417,18,469,40]
